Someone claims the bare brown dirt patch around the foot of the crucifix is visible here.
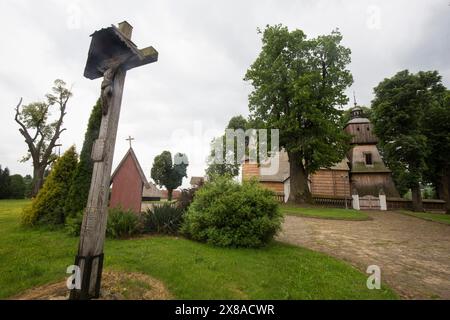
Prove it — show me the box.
[12,272,172,300]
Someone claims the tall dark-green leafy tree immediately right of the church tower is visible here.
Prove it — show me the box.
[372,70,445,211]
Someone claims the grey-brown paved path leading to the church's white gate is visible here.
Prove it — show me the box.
[278,211,450,299]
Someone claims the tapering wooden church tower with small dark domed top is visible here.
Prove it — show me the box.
[344,103,400,197]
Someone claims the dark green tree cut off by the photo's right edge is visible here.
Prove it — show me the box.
[423,90,450,214]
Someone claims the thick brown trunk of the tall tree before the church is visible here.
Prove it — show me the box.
[288,152,312,203]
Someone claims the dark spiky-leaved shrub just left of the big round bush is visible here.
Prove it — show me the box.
[144,203,184,234]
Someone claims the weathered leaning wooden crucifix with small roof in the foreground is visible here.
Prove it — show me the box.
[70,21,158,300]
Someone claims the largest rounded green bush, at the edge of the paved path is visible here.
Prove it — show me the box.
[182,177,283,247]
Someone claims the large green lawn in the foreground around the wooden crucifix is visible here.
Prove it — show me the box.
[0,200,397,299]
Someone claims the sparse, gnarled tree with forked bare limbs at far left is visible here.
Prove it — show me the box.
[14,79,72,197]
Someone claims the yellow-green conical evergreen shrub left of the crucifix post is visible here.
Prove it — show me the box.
[22,146,78,226]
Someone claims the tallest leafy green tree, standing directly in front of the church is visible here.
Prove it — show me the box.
[244,25,353,203]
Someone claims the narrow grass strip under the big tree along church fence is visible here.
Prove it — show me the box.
[281,204,370,220]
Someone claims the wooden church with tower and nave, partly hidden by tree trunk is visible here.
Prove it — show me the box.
[242,106,399,201]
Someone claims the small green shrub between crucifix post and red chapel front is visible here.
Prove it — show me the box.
[106,208,141,239]
